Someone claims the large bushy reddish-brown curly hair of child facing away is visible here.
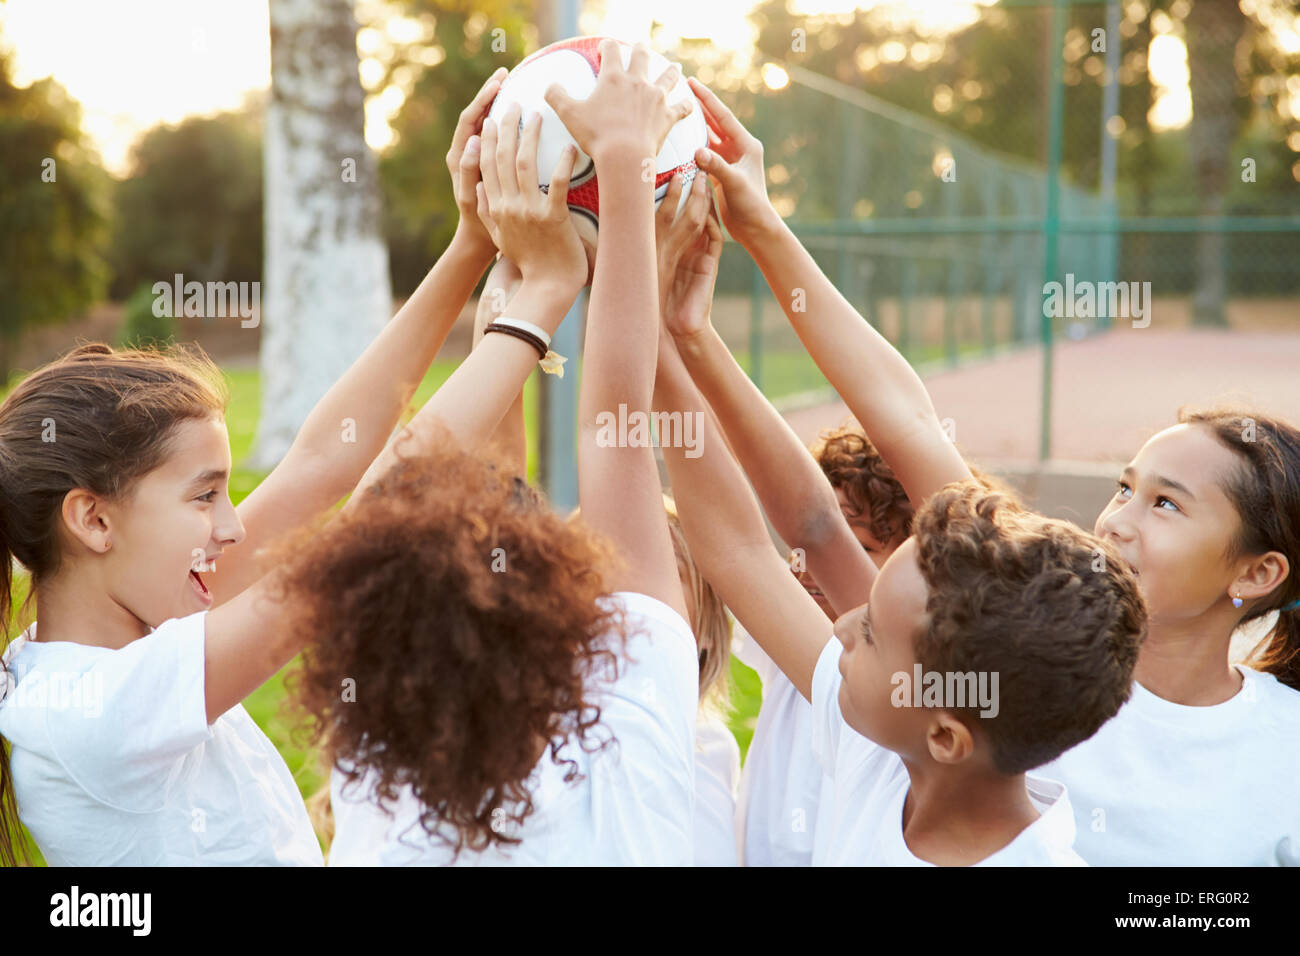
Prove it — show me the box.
[271,441,624,855]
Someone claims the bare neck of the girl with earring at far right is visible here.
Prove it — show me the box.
[1134,614,1242,706]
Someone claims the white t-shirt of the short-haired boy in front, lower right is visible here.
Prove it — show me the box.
[813,637,1087,866]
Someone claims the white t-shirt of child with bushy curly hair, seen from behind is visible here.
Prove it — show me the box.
[330,592,699,866]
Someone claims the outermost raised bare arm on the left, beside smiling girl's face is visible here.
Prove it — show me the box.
[207,68,506,605]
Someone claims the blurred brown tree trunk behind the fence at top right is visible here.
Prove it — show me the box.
[1187,0,1245,328]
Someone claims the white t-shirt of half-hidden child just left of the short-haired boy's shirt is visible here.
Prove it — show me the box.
[732,624,831,866]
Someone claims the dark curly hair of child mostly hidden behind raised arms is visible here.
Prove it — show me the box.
[813,425,913,548]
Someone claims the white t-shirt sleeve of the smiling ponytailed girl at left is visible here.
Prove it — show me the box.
[46,611,212,810]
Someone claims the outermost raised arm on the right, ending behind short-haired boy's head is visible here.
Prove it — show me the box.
[690,78,971,506]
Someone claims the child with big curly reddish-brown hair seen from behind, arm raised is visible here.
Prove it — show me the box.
[310,40,699,865]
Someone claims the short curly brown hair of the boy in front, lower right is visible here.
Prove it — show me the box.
[913,481,1147,774]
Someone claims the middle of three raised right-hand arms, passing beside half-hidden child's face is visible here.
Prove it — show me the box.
[655,176,876,614]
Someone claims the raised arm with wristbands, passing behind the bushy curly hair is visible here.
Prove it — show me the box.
[204,100,586,722]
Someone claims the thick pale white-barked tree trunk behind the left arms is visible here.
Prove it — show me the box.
[250,0,393,470]
